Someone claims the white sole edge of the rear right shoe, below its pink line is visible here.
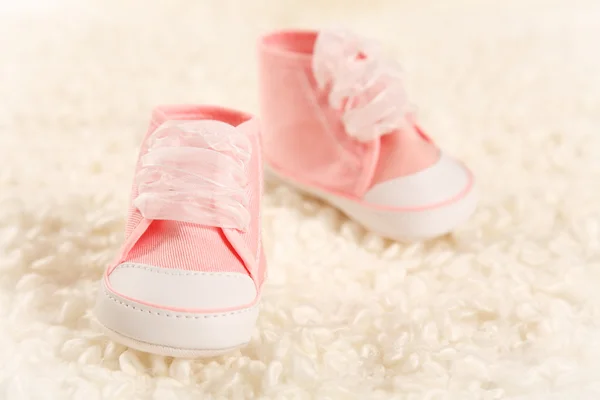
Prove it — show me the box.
[264,165,477,241]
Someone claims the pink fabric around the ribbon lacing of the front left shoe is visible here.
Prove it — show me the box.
[108,106,265,286]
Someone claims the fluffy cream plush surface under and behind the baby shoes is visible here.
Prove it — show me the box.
[0,0,600,400]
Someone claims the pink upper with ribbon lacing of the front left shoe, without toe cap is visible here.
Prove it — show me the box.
[105,106,265,294]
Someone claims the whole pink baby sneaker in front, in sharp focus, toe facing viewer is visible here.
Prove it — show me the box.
[95,106,266,358]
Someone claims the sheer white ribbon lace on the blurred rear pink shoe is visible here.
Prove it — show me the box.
[312,31,412,141]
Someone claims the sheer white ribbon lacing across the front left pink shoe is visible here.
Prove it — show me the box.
[134,121,251,230]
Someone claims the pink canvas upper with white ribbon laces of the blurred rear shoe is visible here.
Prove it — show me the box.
[259,31,440,199]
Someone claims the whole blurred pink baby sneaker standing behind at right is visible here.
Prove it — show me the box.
[259,31,477,240]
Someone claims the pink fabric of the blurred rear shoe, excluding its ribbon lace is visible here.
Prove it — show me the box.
[259,31,439,198]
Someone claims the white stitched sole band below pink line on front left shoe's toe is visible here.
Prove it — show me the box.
[94,282,258,358]
